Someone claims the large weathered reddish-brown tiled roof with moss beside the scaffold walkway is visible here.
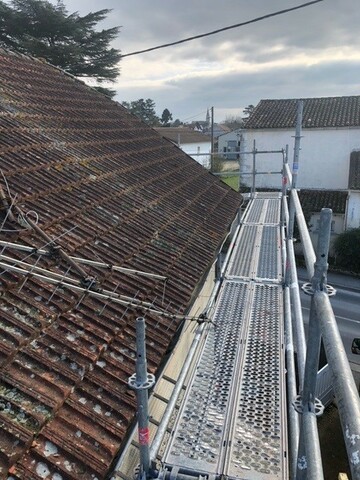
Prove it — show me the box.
[0,52,240,480]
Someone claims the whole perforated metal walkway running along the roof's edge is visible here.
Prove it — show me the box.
[163,193,288,480]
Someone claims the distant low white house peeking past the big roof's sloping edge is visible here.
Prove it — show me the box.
[155,127,211,168]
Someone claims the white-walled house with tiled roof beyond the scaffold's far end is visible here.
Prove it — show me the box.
[241,95,360,229]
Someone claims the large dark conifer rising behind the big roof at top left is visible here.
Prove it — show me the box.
[0,0,121,94]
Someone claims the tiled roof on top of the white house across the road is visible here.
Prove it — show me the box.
[245,95,360,129]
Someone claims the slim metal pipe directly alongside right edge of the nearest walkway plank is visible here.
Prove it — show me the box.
[284,287,300,478]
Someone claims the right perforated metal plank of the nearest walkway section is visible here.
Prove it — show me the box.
[224,285,287,480]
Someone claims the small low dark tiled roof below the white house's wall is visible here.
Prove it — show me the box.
[299,189,348,213]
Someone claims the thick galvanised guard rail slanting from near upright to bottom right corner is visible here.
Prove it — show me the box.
[314,291,360,479]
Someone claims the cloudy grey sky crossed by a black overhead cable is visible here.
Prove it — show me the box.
[65,0,360,121]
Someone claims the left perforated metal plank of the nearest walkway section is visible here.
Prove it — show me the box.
[164,282,249,474]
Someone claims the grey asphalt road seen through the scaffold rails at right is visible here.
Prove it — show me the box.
[298,268,360,372]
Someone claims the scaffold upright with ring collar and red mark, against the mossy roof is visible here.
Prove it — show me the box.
[129,317,155,480]
